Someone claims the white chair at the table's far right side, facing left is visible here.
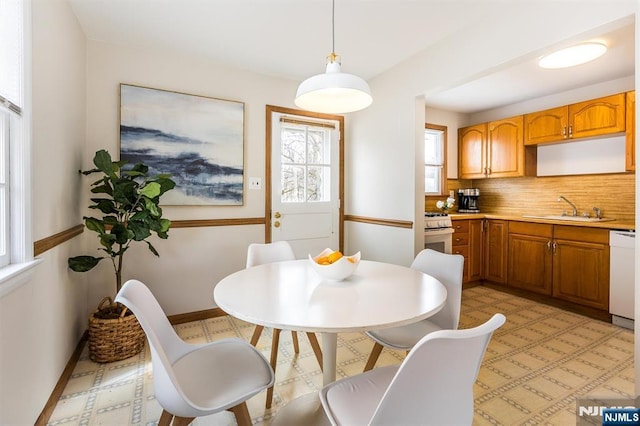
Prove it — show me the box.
[364,249,464,371]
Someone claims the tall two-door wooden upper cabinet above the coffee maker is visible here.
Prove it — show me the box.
[458,115,536,179]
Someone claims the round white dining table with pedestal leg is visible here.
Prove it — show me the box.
[213,259,447,424]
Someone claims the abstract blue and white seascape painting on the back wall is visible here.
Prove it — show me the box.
[120,84,244,206]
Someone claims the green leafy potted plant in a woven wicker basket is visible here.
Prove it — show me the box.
[68,150,175,362]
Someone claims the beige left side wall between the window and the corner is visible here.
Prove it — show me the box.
[0,1,87,425]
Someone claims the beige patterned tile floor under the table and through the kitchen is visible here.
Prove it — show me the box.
[49,287,634,425]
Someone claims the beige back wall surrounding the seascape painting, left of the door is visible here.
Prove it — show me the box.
[82,41,297,315]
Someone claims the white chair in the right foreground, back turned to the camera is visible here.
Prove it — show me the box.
[320,314,506,426]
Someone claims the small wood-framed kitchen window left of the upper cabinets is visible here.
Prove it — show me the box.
[424,124,447,195]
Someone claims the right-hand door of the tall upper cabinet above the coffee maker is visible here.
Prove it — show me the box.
[487,115,524,178]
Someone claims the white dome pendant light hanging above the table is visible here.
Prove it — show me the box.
[295,0,373,114]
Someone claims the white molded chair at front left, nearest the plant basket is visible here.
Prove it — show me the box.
[115,280,274,425]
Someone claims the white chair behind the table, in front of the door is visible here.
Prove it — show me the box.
[247,241,322,408]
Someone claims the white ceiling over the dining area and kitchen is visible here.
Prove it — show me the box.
[69,0,635,112]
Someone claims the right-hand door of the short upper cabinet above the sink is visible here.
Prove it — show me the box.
[569,93,626,138]
